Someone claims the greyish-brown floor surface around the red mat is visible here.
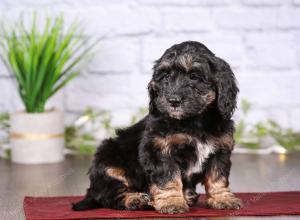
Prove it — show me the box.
[0,154,300,220]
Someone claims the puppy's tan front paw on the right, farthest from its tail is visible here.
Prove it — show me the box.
[205,194,243,209]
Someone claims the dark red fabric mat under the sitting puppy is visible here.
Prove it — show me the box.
[24,191,300,220]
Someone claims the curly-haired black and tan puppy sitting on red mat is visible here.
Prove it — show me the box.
[73,41,242,214]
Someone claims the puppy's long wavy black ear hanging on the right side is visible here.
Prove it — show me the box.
[207,55,239,119]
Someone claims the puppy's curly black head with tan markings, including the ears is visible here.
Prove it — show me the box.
[148,41,238,119]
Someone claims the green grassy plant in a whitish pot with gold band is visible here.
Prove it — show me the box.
[0,15,97,164]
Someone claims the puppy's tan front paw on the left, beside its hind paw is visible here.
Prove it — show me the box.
[156,198,189,214]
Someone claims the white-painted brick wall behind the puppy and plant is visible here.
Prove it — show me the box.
[0,0,300,129]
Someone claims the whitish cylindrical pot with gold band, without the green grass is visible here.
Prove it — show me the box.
[10,110,65,164]
